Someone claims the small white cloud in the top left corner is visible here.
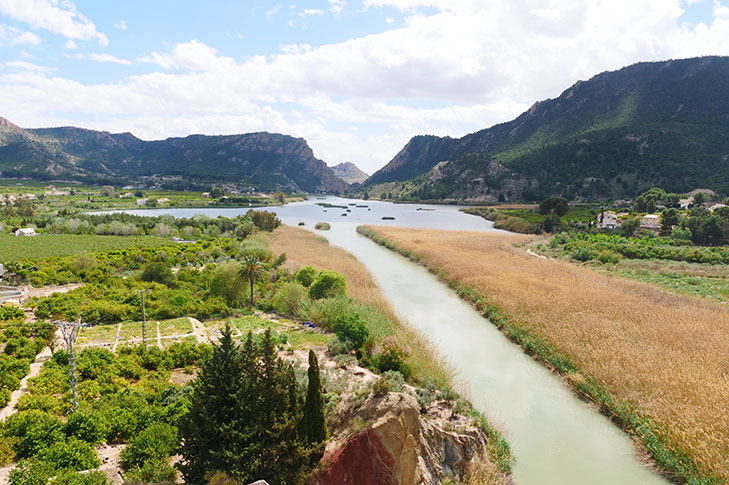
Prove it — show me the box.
[0,0,109,45]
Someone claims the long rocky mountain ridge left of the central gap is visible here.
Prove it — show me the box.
[0,118,348,192]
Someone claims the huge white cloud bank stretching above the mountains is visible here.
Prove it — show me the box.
[0,0,729,171]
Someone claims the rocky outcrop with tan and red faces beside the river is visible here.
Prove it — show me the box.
[314,392,500,485]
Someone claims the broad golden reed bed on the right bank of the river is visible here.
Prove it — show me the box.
[369,227,729,481]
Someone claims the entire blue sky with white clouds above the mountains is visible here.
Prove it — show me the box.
[0,0,729,173]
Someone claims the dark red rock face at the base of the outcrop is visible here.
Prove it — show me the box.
[314,428,398,485]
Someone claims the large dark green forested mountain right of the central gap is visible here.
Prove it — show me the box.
[365,57,729,201]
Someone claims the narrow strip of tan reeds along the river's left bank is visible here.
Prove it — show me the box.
[269,226,453,385]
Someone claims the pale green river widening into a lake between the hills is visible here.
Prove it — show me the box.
[114,197,667,485]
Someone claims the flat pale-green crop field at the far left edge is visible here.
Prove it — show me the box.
[0,234,171,263]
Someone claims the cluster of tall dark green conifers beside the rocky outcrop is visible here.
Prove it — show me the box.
[179,326,326,484]
